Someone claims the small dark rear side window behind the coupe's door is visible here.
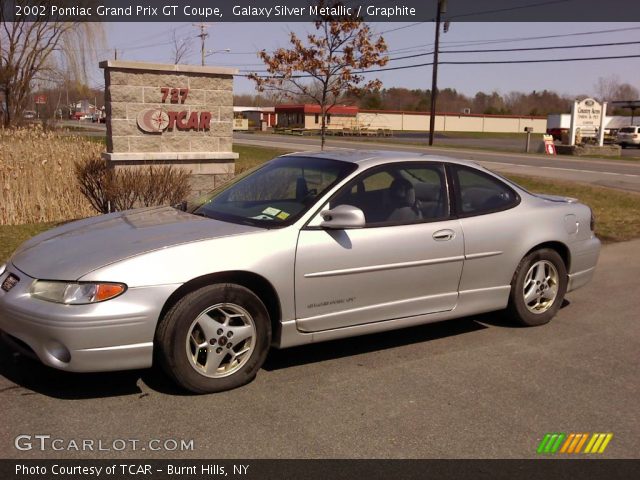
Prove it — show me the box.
[453,165,520,216]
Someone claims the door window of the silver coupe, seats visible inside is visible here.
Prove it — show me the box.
[329,163,449,227]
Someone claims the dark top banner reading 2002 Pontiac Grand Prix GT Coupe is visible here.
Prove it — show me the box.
[0,0,640,22]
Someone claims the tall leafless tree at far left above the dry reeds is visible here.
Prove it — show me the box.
[0,0,104,127]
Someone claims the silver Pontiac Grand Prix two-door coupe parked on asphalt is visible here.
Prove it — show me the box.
[0,151,600,393]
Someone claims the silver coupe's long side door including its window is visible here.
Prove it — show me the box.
[295,162,464,332]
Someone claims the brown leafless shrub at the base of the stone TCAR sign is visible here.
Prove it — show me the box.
[75,158,189,213]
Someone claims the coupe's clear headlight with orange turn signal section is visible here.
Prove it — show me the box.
[31,280,127,305]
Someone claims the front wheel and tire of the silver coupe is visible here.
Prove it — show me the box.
[155,283,271,393]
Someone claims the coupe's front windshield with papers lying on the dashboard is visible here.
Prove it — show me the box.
[193,156,356,228]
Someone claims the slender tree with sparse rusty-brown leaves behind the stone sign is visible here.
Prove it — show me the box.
[249,6,388,148]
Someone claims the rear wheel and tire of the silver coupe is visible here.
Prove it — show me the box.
[507,248,567,327]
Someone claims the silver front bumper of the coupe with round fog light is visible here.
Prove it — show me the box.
[0,263,180,372]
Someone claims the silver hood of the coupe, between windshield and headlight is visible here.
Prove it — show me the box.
[11,207,262,281]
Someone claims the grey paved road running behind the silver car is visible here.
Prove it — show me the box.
[233,132,640,192]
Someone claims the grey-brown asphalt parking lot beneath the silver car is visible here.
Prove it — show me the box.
[0,240,640,459]
